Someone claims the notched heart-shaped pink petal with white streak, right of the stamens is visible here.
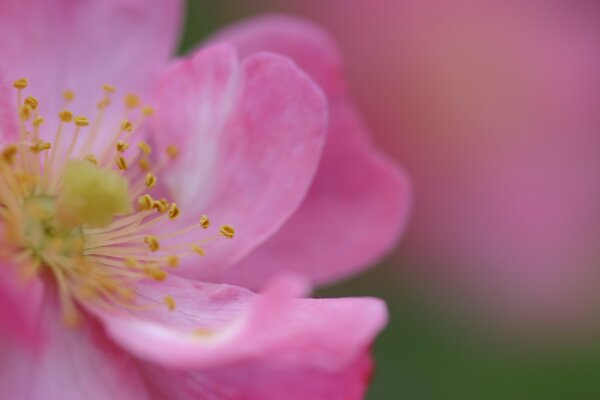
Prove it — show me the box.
[153,45,327,276]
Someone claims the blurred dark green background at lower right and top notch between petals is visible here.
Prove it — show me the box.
[180,0,600,400]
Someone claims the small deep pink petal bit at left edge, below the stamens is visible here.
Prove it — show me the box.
[0,261,44,347]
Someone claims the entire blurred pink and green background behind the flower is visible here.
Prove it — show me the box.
[181,0,600,400]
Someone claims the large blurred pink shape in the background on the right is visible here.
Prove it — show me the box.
[258,0,600,331]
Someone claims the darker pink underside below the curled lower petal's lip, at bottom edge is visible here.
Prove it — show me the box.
[135,354,372,400]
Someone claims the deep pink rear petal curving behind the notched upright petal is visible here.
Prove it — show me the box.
[206,16,411,287]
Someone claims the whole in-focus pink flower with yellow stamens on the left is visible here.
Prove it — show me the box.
[0,0,408,400]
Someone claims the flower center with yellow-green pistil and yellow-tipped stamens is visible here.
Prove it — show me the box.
[0,79,235,325]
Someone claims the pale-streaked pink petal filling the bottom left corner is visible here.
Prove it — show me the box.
[0,293,149,400]
